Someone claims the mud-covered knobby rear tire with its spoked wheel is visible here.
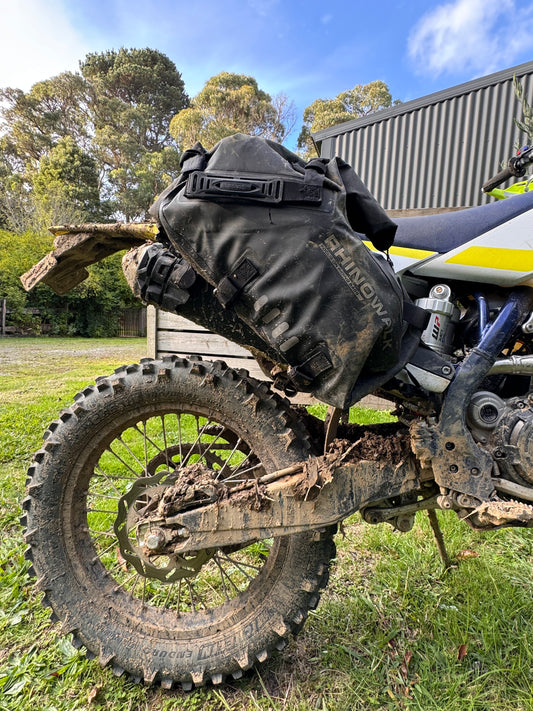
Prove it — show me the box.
[24,357,335,689]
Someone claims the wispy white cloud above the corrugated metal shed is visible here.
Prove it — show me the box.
[408,0,533,76]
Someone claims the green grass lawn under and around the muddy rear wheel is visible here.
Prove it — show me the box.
[0,339,533,711]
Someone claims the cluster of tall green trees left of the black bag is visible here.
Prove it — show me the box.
[0,48,188,229]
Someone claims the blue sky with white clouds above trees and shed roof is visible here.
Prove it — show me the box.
[0,0,533,147]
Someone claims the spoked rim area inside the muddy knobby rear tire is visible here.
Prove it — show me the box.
[84,408,279,617]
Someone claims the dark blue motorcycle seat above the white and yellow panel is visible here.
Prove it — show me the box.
[388,192,533,254]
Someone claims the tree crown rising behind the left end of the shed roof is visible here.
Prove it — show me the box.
[298,79,400,155]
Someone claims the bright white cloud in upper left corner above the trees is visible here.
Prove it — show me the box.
[0,0,87,91]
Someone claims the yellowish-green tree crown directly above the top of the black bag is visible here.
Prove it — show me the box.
[170,72,294,149]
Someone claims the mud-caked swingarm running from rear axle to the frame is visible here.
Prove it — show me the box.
[131,457,422,555]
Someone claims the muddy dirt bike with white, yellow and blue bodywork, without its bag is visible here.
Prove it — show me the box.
[23,135,533,689]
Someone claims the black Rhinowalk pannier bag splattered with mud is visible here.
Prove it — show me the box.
[151,134,412,408]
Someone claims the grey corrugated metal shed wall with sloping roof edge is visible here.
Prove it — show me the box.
[314,62,533,210]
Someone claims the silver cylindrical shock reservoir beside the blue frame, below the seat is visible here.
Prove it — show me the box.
[415,284,461,355]
